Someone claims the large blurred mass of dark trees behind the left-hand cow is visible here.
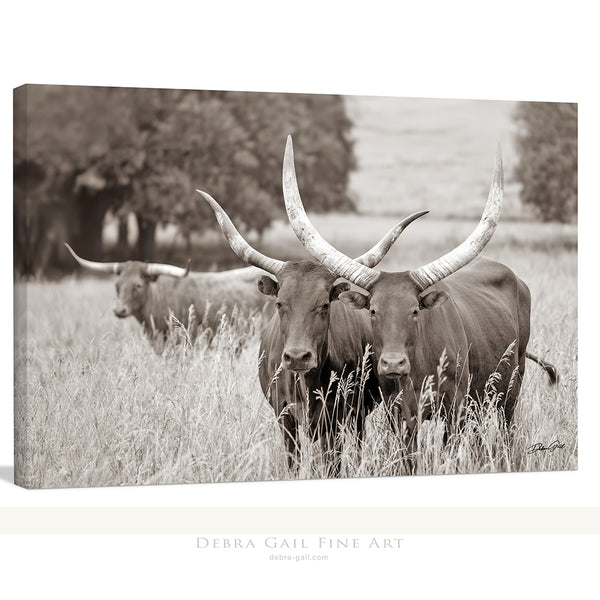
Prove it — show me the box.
[14,86,355,272]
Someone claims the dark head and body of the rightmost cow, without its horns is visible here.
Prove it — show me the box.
[340,259,531,432]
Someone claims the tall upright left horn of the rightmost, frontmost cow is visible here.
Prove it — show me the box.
[283,135,379,290]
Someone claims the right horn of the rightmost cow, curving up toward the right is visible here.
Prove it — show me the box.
[410,144,504,290]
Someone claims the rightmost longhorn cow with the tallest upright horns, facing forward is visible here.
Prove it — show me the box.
[283,137,555,439]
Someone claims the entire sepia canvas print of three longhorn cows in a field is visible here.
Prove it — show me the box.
[14,85,577,488]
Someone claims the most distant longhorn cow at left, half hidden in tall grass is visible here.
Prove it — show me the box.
[65,244,273,352]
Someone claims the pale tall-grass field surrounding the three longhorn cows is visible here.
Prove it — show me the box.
[15,215,577,487]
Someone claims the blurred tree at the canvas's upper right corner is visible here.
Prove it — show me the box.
[514,102,577,222]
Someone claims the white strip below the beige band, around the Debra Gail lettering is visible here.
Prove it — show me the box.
[0,535,598,600]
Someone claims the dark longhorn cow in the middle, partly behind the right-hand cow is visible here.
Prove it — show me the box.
[198,190,427,474]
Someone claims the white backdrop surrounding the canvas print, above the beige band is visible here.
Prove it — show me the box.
[0,0,600,597]
